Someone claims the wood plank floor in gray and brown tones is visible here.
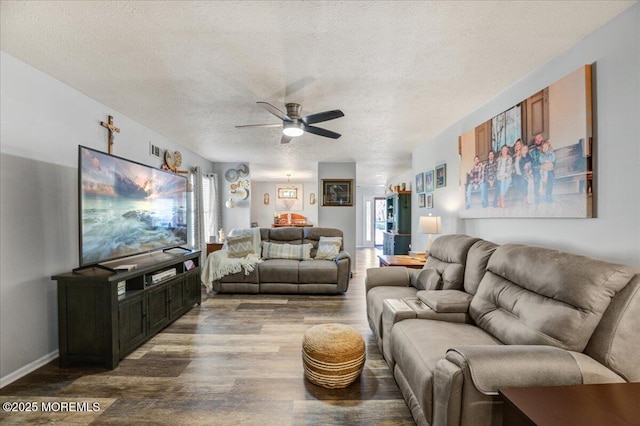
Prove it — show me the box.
[0,249,414,425]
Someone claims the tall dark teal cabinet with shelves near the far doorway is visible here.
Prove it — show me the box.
[382,191,411,255]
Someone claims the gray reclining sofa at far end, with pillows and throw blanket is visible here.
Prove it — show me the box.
[213,227,351,294]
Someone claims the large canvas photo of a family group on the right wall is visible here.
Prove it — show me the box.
[459,65,595,218]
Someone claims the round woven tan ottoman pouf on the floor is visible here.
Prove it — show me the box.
[302,324,365,389]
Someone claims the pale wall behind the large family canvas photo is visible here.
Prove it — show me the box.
[412,4,640,266]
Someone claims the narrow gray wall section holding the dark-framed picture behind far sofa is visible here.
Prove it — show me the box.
[317,163,359,269]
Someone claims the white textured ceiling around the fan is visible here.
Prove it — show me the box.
[0,1,634,185]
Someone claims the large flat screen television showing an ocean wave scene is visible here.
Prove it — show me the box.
[78,146,187,267]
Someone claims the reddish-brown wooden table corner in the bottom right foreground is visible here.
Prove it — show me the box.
[499,383,640,426]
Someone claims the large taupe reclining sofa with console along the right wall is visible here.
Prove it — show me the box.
[366,235,640,425]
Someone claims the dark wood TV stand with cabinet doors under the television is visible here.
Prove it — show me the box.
[52,250,202,369]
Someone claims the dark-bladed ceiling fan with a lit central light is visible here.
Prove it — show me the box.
[236,102,344,143]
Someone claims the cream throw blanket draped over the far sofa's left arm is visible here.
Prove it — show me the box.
[200,228,262,292]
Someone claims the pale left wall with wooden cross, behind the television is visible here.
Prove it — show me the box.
[0,52,213,386]
